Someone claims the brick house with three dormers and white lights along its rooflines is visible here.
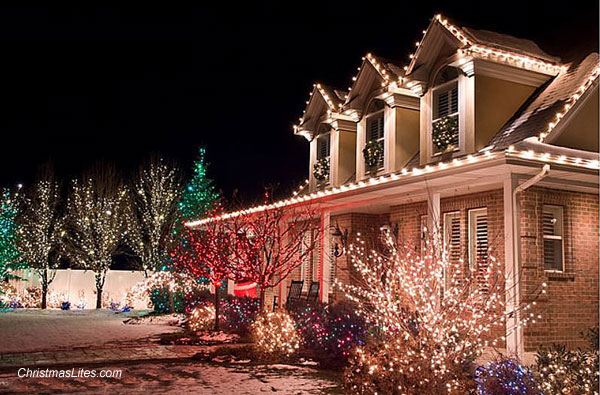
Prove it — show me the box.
[189,15,599,355]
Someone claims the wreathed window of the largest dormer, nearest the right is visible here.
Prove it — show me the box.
[431,67,459,154]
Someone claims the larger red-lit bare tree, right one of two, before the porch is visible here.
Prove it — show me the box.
[226,205,320,310]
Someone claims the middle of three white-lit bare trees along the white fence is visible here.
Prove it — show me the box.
[67,164,131,309]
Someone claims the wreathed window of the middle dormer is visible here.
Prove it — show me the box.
[363,100,385,173]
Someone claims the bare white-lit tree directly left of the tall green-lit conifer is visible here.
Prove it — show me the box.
[127,157,183,276]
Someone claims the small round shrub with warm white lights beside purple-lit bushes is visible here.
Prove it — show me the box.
[252,311,300,357]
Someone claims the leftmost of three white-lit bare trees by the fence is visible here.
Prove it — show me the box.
[18,165,65,309]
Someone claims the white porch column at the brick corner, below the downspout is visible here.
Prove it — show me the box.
[504,174,524,358]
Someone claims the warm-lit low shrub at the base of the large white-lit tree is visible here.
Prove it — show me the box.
[343,336,475,394]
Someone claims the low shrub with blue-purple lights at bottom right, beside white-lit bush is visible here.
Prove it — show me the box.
[475,360,543,395]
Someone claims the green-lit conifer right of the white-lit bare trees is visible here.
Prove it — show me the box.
[179,148,221,222]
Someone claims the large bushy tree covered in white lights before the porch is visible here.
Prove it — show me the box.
[335,227,545,394]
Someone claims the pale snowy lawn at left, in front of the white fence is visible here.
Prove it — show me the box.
[0,309,181,354]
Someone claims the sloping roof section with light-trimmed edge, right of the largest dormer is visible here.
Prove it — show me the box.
[489,53,599,150]
